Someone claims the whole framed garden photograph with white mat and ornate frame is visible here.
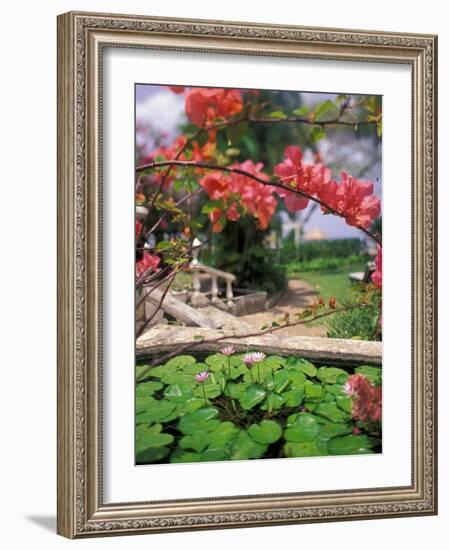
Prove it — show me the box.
[58,12,437,538]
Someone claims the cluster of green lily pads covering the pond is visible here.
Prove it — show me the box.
[136,353,381,464]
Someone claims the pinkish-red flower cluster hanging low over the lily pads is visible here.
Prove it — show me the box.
[343,374,382,422]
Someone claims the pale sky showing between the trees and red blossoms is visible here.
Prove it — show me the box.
[135,84,382,239]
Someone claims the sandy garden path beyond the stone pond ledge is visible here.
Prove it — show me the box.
[239,279,326,336]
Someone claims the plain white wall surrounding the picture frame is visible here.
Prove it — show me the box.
[0,0,449,550]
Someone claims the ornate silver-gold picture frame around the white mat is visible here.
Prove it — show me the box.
[57,12,437,538]
